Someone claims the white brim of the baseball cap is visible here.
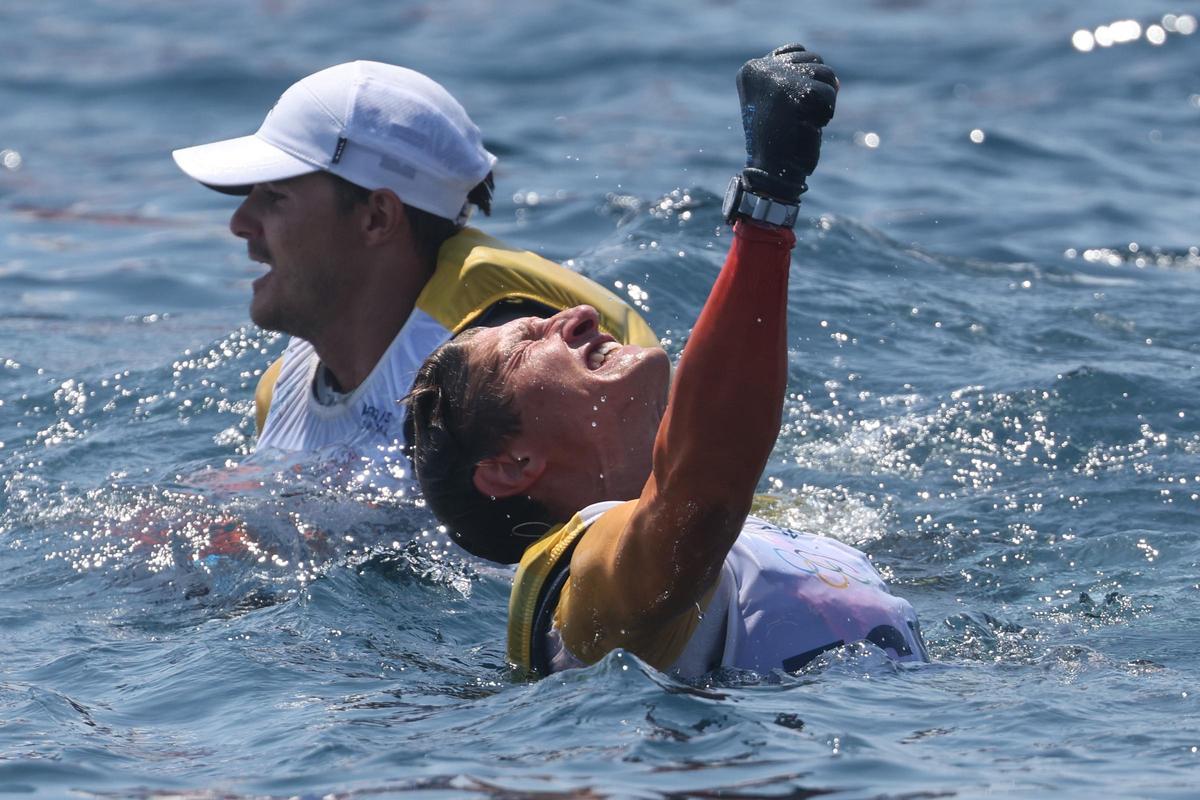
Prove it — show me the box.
[170,136,320,194]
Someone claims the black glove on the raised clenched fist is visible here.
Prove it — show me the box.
[738,44,838,204]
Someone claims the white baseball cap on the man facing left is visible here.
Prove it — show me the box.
[172,61,496,221]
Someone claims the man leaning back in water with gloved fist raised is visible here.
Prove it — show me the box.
[410,46,925,675]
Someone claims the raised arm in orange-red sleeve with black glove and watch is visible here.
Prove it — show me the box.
[559,46,838,667]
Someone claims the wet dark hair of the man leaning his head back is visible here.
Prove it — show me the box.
[404,327,554,564]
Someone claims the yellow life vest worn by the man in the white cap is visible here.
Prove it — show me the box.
[254,228,659,433]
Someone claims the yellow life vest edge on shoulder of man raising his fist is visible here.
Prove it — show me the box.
[508,515,588,676]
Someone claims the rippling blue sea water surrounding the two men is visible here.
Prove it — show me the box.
[0,0,1200,798]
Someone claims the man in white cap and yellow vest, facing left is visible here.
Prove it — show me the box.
[174,61,656,469]
